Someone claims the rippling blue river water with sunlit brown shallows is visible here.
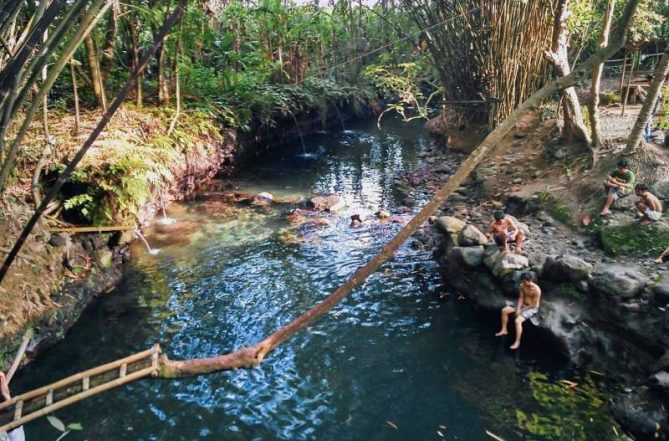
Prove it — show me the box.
[14,120,610,441]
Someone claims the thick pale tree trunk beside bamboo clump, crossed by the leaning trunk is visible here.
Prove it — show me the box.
[544,0,590,145]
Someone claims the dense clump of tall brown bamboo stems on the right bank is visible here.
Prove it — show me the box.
[403,0,552,125]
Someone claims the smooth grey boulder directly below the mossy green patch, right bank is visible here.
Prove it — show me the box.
[590,265,646,299]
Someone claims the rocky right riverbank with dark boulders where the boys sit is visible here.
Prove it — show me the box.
[406,111,669,439]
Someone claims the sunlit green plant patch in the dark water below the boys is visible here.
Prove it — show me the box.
[516,372,622,441]
